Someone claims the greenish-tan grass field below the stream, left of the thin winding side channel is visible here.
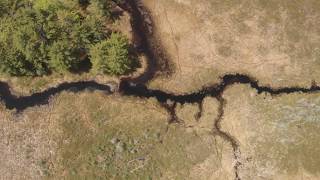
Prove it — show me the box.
[0,92,233,179]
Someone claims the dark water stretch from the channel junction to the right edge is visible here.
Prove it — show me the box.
[120,74,320,104]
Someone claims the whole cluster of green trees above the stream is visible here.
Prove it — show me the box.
[0,0,133,76]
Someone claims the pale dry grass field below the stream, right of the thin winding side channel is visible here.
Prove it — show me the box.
[222,85,320,180]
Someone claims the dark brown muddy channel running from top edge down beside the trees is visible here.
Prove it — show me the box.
[113,0,173,84]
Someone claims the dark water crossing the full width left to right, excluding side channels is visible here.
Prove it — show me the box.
[0,74,320,111]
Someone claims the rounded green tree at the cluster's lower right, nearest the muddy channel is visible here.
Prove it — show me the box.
[90,33,133,75]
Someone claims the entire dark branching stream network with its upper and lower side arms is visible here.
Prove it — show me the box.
[0,0,320,179]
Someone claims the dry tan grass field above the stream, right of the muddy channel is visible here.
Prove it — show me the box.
[143,0,320,92]
